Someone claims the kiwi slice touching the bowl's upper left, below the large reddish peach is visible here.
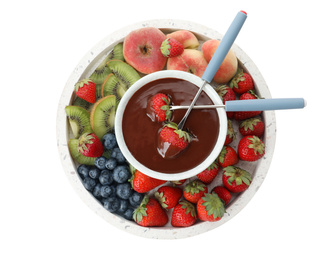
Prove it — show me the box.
[107,60,140,90]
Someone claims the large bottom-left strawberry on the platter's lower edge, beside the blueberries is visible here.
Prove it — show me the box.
[133,195,169,227]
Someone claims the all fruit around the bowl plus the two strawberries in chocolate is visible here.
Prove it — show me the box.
[65,27,265,227]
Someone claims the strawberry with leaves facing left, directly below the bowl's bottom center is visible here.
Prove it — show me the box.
[154,186,183,209]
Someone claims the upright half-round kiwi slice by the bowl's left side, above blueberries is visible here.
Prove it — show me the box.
[90,95,117,140]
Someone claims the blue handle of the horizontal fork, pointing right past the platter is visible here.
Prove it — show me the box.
[225,98,306,112]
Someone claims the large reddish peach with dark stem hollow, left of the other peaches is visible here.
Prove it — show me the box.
[123,27,167,74]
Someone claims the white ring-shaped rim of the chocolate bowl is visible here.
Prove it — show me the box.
[115,70,228,181]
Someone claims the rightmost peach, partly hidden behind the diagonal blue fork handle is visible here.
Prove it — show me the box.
[202,39,238,84]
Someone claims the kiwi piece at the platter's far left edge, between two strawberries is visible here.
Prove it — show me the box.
[65,106,93,138]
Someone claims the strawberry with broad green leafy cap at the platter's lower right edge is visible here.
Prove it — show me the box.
[222,166,252,193]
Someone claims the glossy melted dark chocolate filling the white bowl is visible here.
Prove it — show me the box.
[122,78,219,173]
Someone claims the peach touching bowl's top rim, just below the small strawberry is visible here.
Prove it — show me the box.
[167,49,208,77]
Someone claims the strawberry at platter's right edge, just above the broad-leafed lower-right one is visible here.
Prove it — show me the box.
[238,135,265,162]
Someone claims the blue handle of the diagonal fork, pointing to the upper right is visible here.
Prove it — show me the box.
[201,11,247,83]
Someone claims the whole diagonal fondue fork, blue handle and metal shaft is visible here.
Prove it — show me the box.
[178,11,247,129]
